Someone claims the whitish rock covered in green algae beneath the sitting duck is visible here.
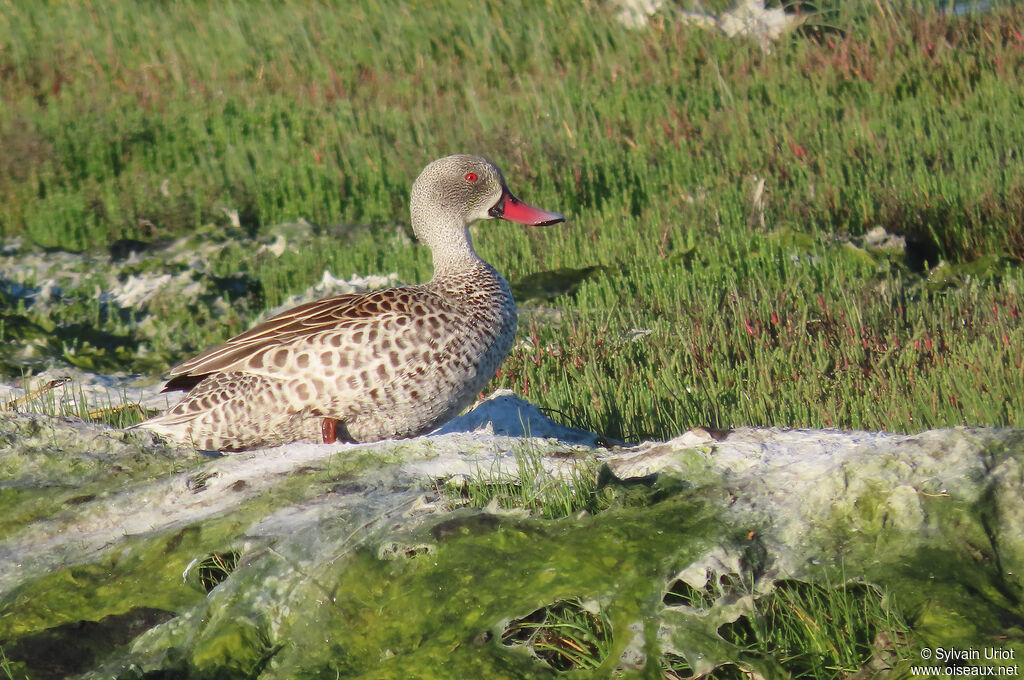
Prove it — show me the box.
[0,393,1024,678]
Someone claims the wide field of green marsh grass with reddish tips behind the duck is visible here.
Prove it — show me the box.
[0,0,1024,439]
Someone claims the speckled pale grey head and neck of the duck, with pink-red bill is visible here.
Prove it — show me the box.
[410,154,565,274]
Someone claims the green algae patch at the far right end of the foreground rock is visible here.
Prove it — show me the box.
[823,433,1024,657]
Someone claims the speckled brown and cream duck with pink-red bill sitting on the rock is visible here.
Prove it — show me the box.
[136,154,565,452]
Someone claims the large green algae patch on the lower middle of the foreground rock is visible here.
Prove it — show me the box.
[110,491,725,678]
